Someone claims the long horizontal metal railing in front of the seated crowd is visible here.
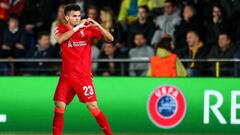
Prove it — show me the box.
[0,57,240,77]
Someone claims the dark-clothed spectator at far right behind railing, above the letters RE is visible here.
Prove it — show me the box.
[208,32,237,76]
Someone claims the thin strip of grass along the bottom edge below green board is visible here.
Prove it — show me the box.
[0,132,237,135]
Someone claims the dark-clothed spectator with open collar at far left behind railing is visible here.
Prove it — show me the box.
[0,15,28,75]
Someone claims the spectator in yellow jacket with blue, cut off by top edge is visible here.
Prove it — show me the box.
[118,0,148,24]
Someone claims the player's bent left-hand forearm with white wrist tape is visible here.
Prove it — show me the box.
[55,19,87,44]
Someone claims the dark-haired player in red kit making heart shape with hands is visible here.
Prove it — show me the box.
[52,4,114,135]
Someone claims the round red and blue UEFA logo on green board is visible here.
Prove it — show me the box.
[147,85,187,128]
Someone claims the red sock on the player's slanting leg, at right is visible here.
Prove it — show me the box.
[90,108,112,135]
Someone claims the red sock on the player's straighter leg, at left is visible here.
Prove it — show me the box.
[52,107,64,135]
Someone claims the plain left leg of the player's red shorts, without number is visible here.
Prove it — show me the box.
[54,79,75,105]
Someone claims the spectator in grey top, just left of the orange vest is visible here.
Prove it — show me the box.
[129,32,154,76]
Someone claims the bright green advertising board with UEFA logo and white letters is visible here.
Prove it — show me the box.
[0,77,240,134]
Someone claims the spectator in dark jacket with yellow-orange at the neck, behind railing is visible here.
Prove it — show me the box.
[180,31,208,76]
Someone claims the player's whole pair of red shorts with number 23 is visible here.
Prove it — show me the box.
[54,77,97,104]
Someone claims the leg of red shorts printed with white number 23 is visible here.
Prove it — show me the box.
[73,78,96,102]
